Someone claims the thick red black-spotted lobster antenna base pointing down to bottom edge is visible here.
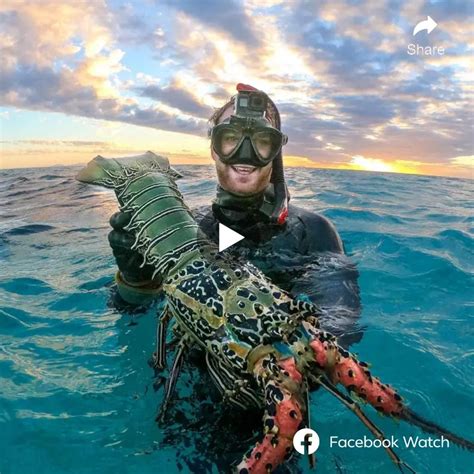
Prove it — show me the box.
[237,356,306,474]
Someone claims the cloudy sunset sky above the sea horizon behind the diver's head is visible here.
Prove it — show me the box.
[0,0,474,178]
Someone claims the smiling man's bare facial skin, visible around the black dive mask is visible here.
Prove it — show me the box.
[211,106,272,196]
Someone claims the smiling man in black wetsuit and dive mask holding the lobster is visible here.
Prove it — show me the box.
[109,84,360,345]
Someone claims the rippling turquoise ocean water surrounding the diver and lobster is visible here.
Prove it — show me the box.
[0,167,474,474]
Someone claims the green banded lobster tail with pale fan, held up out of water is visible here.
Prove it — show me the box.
[76,151,210,277]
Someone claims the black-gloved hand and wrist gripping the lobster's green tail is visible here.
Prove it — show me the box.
[109,212,162,304]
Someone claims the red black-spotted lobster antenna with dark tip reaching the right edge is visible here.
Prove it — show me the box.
[305,325,474,451]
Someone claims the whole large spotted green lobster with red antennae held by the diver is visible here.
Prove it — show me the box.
[77,152,474,473]
